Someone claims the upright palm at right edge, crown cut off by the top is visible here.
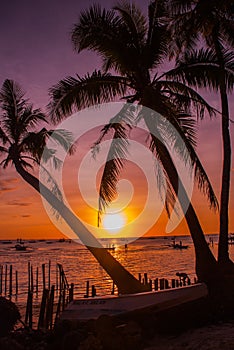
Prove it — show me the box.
[168,0,234,265]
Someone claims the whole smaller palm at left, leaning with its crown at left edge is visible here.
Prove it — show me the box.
[0,80,148,294]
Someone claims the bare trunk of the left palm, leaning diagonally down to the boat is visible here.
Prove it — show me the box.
[14,160,149,294]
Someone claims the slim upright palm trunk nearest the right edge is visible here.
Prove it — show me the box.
[213,36,231,264]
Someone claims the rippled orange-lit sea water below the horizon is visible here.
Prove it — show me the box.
[0,235,231,320]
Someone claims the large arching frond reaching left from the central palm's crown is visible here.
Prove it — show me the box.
[48,71,127,122]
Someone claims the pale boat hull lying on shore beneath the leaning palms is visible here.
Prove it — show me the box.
[60,283,208,321]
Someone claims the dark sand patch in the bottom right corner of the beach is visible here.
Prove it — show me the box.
[145,322,234,350]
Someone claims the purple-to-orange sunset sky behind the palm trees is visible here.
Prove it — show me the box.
[0,0,234,239]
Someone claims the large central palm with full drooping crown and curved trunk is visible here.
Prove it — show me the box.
[49,0,217,281]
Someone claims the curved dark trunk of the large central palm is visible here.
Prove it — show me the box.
[142,108,217,284]
